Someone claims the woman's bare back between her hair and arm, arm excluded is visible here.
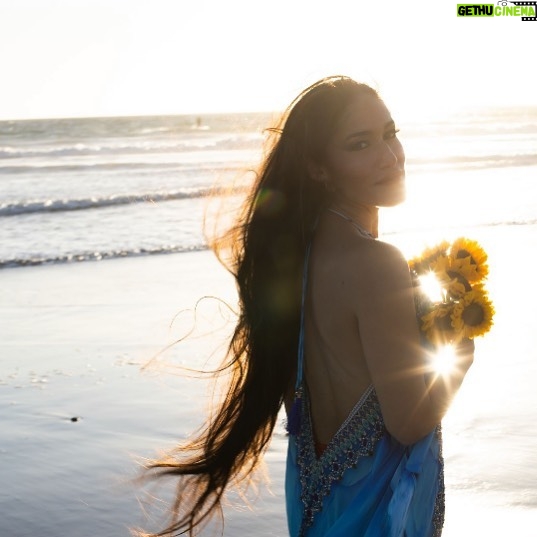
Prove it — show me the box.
[305,215,371,444]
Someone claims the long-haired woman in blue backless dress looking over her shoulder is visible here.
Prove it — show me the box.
[142,76,473,537]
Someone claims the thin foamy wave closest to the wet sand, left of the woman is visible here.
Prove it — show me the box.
[0,244,208,269]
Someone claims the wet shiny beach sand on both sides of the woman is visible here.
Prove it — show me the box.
[0,226,537,537]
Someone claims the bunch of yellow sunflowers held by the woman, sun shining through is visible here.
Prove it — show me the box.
[409,238,494,345]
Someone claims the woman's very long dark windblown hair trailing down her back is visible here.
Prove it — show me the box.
[140,76,378,535]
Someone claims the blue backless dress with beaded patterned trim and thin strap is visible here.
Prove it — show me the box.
[285,237,444,537]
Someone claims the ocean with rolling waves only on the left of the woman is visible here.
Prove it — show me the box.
[0,114,266,267]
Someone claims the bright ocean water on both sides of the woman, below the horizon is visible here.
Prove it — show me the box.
[0,108,537,267]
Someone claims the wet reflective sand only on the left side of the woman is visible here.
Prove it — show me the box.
[0,252,285,537]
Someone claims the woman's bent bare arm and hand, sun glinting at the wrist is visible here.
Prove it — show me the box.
[351,241,474,444]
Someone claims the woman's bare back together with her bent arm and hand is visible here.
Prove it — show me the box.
[304,209,474,444]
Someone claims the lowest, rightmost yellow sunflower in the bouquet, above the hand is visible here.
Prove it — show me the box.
[451,285,494,340]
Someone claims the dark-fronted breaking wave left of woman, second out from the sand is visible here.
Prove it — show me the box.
[0,187,245,217]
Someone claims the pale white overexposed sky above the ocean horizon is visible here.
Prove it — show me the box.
[0,0,537,120]
